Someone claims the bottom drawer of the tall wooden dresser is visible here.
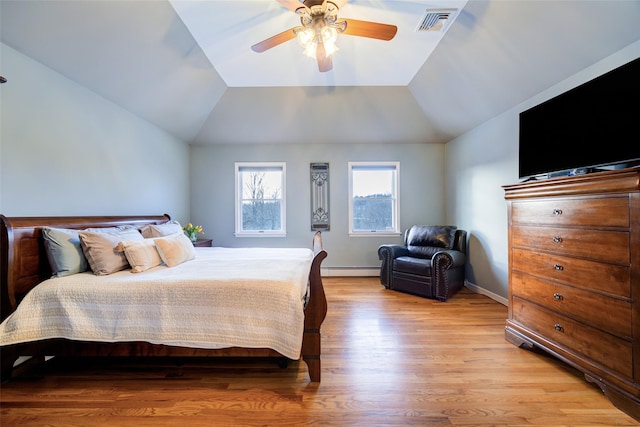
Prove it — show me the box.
[512,297,633,378]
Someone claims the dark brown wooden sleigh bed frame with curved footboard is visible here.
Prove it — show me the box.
[0,215,327,382]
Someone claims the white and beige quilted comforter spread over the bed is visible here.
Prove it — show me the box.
[0,248,313,359]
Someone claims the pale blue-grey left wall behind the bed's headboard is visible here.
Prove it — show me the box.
[0,44,189,220]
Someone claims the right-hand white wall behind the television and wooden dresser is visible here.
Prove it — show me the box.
[445,42,640,302]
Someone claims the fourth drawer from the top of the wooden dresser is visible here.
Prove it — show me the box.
[511,271,633,340]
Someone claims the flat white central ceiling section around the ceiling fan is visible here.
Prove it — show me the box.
[170,0,467,87]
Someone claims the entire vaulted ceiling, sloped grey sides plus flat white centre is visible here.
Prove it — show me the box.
[0,0,640,144]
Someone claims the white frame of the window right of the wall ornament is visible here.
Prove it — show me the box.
[348,161,400,237]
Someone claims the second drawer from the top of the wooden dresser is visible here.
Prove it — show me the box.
[511,226,630,264]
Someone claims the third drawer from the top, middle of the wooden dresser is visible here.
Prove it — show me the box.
[511,249,631,298]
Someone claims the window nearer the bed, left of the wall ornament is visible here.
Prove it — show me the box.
[236,163,286,236]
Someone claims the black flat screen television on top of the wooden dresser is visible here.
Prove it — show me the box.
[519,58,640,180]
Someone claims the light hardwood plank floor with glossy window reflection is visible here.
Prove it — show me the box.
[0,278,640,427]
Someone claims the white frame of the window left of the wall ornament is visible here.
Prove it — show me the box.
[235,162,287,237]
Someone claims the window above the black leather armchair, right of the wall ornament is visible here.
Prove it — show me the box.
[349,162,400,235]
